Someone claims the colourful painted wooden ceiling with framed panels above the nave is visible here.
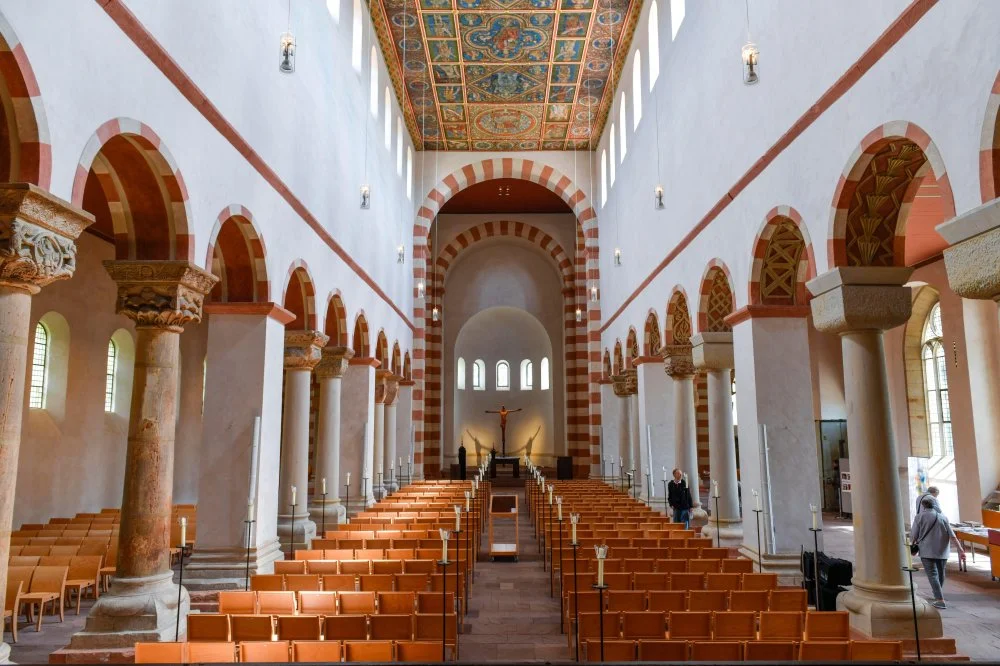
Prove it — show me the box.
[371,0,642,151]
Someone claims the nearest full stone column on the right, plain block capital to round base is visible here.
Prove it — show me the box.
[806,267,941,638]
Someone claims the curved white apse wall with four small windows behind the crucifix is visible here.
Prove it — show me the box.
[448,306,565,467]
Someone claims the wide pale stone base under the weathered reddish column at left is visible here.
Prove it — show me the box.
[69,567,191,650]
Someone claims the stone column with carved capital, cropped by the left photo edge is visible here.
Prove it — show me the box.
[0,183,94,663]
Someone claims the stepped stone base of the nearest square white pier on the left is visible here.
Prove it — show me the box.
[184,539,284,590]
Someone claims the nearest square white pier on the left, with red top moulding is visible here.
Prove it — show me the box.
[184,303,295,590]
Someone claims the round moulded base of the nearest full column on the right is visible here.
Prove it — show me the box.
[837,585,944,640]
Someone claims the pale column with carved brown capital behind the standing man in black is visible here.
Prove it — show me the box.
[663,343,708,525]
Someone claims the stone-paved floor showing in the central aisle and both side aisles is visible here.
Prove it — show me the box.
[4,504,1000,664]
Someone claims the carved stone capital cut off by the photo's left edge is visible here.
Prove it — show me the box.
[0,183,94,294]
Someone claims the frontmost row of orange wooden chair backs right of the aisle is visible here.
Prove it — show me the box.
[584,639,903,663]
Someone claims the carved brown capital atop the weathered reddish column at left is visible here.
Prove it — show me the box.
[104,260,219,329]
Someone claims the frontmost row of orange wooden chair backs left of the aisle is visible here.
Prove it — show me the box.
[135,641,441,664]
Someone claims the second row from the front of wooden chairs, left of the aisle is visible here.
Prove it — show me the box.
[187,611,458,644]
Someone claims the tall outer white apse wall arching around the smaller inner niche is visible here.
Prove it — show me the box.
[441,239,566,465]
